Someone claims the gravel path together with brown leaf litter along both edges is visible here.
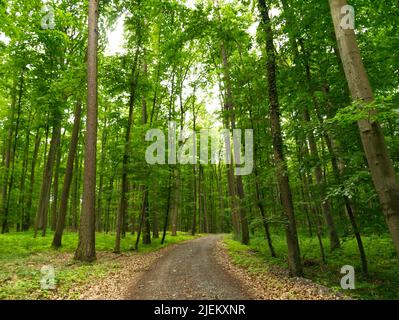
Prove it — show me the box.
[72,235,348,300]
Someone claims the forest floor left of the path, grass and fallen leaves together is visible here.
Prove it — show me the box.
[0,232,201,300]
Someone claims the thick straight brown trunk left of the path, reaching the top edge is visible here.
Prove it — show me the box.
[75,0,98,261]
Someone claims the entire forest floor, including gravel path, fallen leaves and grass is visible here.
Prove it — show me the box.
[0,232,398,300]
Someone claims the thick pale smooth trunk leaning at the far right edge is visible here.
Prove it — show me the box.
[329,0,399,258]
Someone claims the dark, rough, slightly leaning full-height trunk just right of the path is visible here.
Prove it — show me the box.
[258,0,303,276]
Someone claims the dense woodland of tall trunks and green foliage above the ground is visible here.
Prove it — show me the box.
[0,0,399,300]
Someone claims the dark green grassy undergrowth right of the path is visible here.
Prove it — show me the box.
[225,234,399,300]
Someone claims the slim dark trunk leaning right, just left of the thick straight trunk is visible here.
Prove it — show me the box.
[52,101,82,248]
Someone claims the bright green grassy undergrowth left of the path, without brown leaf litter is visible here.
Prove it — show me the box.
[0,232,200,300]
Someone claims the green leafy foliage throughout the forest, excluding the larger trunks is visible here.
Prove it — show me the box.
[0,0,399,298]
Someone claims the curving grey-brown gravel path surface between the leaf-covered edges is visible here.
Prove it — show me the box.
[126,235,251,300]
